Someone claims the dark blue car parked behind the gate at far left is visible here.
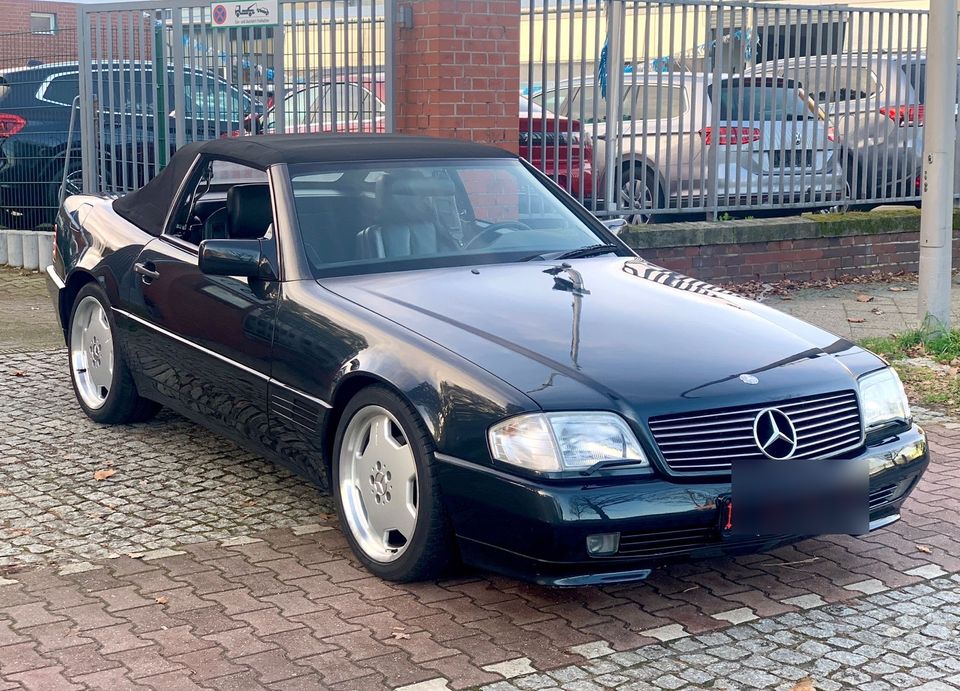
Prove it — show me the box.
[0,62,262,228]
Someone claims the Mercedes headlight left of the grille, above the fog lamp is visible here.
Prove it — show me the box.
[488,413,649,472]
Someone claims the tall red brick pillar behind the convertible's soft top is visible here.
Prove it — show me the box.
[394,0,520,153]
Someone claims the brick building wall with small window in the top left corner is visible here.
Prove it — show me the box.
[0,0,77,68]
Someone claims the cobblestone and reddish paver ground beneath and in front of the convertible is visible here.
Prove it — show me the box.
[0,274,960,691]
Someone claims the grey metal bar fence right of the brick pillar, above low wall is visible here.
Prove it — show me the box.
[520,0,960,221]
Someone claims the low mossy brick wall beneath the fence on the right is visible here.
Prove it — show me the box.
[621,211,960,283]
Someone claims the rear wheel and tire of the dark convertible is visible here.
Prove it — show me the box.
[67,283,160,425]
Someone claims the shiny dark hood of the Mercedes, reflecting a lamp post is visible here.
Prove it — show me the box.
[321,257,883,418]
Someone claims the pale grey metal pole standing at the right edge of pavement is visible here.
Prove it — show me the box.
[919,0,957,332]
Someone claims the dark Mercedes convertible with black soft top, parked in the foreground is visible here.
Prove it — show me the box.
[47,134,928,585]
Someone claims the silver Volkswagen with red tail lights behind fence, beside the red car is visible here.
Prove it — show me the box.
[532,73,848,222]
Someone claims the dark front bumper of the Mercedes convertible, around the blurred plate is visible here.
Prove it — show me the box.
[438,425,929,586]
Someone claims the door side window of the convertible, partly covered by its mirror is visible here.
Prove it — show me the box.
[166,159,273,245]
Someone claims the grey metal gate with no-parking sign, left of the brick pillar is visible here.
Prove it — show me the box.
[76,0,394,193]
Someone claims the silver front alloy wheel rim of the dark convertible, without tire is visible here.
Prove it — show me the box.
[338,405,419,563]
